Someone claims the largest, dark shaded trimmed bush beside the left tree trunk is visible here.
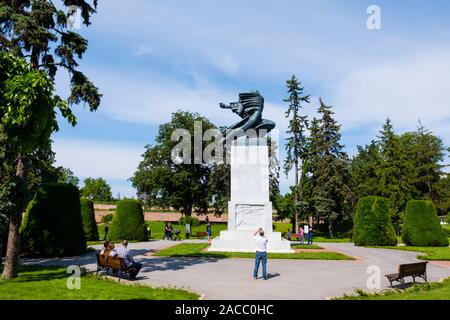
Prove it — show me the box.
[20,183,86,257]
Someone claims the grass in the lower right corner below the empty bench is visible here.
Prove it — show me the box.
[337,278,450,300]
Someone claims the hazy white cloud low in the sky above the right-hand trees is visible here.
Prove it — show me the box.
[331,49,450,143]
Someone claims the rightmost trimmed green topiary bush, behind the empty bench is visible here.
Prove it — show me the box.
[402,200,448,247]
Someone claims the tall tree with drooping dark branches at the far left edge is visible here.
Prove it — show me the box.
[0,0,101,279]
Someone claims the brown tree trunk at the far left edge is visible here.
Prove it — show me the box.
[2,155,29,280]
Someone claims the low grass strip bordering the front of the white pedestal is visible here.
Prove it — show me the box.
[154,243,354,260]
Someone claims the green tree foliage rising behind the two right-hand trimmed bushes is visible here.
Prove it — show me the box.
[350,119,450,233]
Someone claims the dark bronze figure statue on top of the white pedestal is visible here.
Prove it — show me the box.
[220,92,275,143]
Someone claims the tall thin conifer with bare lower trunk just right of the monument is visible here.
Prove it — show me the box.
[284,75,310,230]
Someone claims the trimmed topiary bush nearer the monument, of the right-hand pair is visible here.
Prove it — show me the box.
[353,197,397,246]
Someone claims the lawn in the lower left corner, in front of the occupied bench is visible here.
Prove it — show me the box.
[0,266,199,300]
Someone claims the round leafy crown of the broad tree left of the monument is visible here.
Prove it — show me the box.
[131,111,220,216]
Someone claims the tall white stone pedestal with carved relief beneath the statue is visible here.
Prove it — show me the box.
[209,139,294,253]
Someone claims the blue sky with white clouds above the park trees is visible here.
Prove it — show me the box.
[53,0,450,196]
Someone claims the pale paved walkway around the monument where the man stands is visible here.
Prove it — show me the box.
[21,241,450,300]
